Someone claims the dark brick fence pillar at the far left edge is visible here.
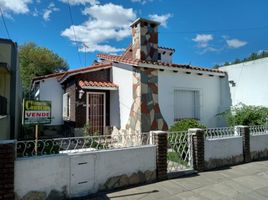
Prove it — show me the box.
[0,140,15,200]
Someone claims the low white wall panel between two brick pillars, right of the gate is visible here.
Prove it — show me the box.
[205,136,243,161]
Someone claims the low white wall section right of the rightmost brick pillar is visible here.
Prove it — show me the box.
[250,134,268,152]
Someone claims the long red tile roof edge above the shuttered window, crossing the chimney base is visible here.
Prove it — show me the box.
[97,54,224,73]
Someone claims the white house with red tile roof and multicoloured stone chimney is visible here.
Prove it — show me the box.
[32,18,230,136]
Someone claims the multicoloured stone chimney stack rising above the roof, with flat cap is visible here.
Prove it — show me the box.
[130,18,160,61]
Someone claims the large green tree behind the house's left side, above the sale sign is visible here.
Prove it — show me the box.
[19,42,69,94]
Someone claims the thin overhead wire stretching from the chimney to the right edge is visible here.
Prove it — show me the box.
[159,26,268,34]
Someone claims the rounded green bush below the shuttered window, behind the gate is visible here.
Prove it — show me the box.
[169,119,206,132]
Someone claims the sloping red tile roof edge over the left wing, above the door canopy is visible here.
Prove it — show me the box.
[33,62,112,81]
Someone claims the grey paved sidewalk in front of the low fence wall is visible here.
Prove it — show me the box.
[93,161,268,200]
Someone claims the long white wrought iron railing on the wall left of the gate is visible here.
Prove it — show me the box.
[16,133,151,157]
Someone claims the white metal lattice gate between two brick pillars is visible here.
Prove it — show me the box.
[167,131,193,177]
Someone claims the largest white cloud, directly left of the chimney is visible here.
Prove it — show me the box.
[61,3,136,53]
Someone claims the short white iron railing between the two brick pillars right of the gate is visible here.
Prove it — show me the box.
[205,127,236,138]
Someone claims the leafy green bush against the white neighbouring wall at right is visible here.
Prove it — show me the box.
[224,104,268,126]
